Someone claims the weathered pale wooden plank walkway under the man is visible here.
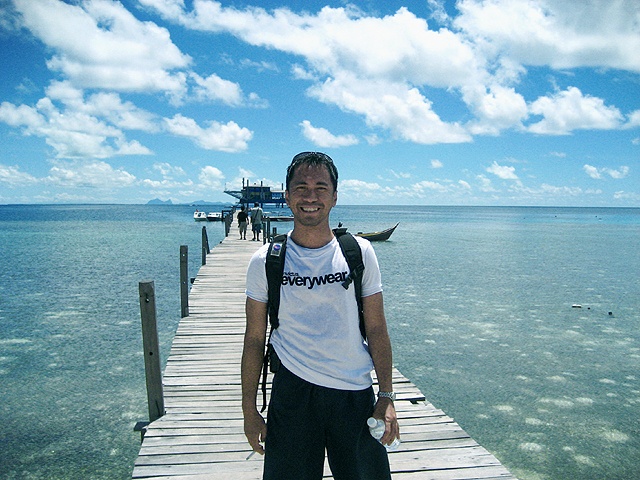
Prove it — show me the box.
[132,228,515,480]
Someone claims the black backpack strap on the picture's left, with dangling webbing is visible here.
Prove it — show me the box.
[261,235,287,412]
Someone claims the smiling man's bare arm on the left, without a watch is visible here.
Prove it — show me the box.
[242,297,267,455]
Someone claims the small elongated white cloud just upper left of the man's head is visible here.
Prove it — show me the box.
[164,114,253,152]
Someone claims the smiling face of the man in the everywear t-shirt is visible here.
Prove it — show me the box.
[285,165,338,227]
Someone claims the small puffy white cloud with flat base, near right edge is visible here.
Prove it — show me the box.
[527,87,623,135]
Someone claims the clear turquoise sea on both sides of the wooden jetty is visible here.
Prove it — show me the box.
[0,205,640,480]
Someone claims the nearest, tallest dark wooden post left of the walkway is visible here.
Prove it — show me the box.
[138,281,164,422]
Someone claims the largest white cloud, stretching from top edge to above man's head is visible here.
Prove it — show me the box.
[143,0,481,144]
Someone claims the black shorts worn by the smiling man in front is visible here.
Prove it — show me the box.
[263,366,391,480]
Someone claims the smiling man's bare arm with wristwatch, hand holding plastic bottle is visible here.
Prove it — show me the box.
[362,292,400,445]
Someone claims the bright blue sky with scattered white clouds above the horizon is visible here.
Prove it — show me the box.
[0,0,640,206]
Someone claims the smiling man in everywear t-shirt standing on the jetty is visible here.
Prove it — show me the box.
[242,152,400,480]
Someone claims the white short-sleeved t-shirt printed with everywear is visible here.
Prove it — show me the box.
[246,232,382,390]
